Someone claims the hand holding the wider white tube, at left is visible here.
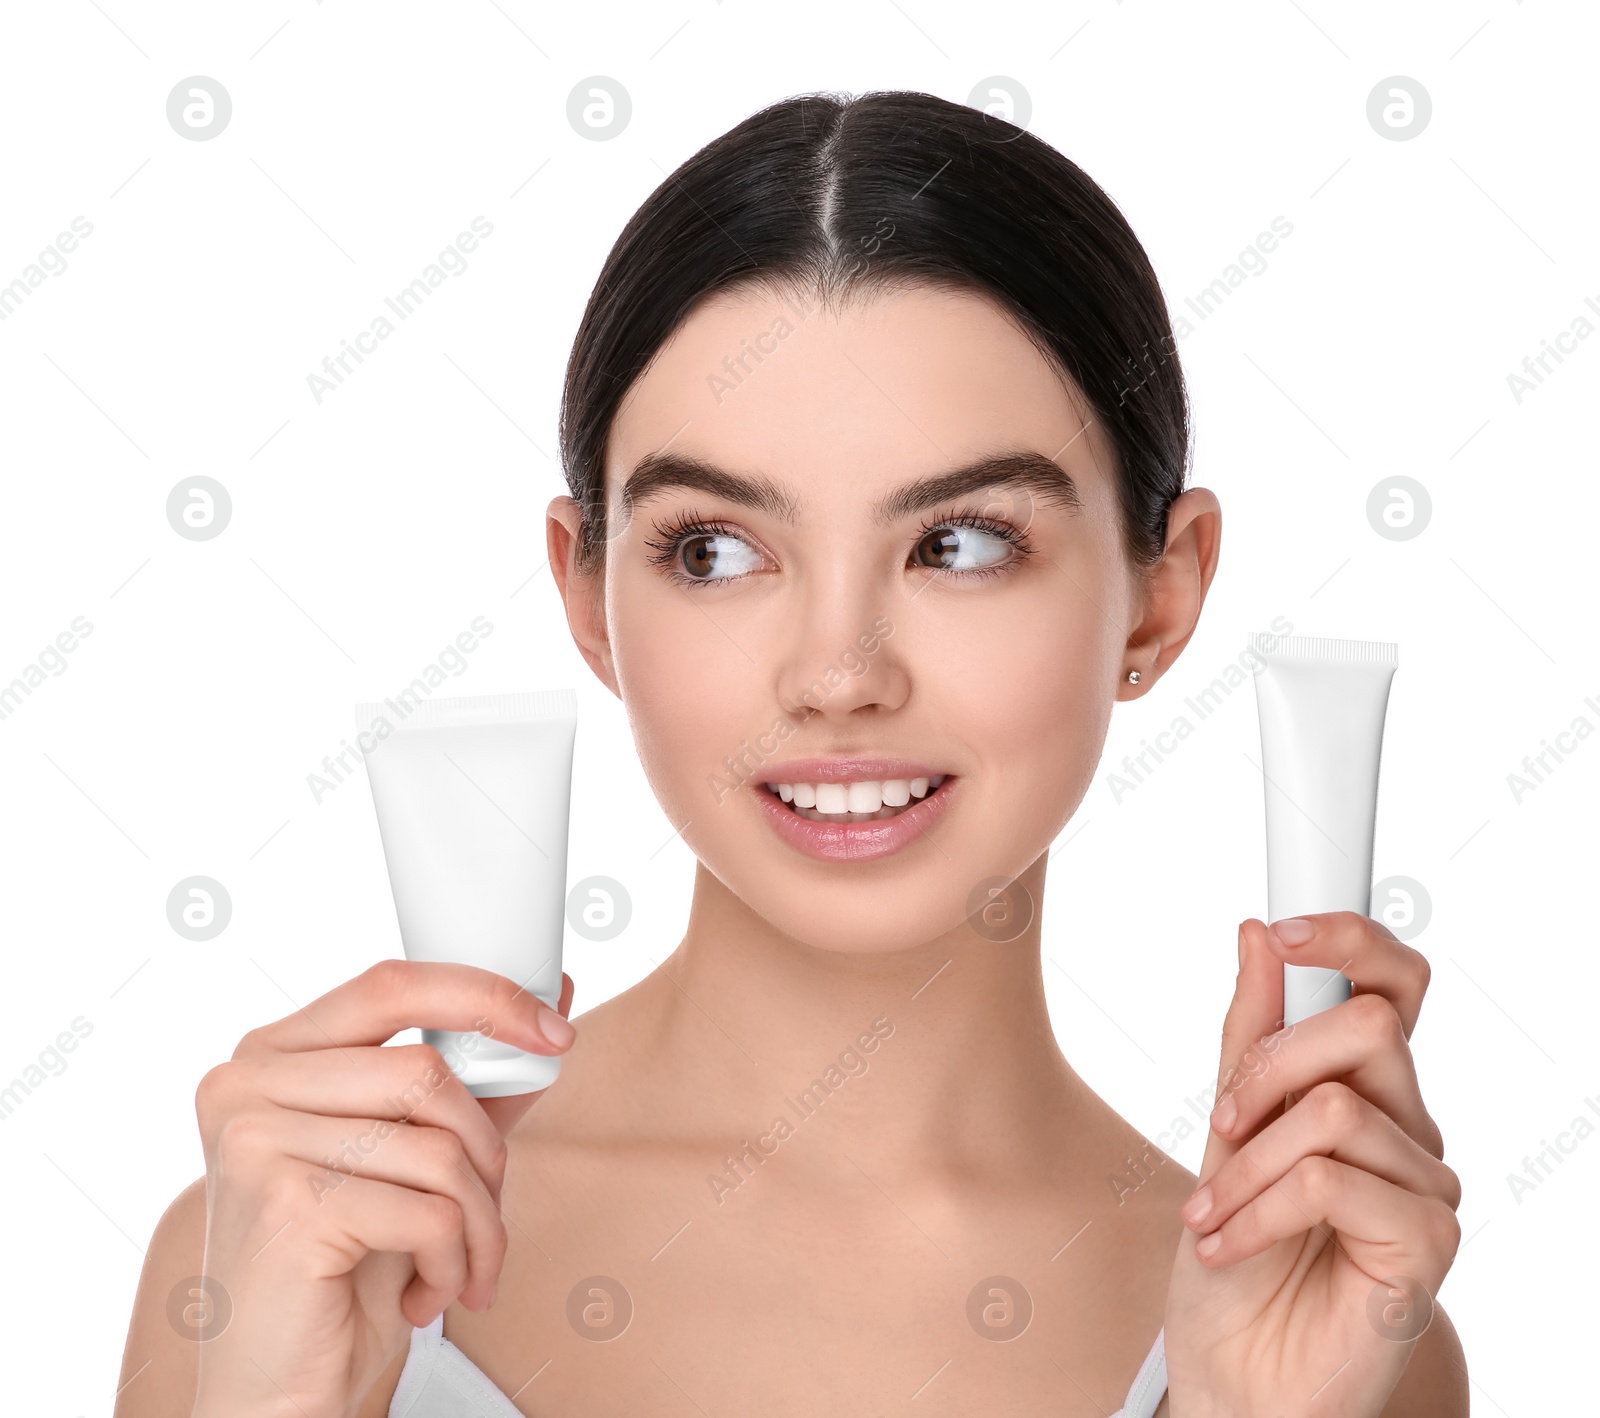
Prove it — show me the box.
[192,960,573,1418]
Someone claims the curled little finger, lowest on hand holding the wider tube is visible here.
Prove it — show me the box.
[312,1176,469,1327]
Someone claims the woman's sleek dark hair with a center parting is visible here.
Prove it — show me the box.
[560,90,1189,570]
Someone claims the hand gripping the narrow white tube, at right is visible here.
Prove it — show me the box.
[1165,911,1461,1418]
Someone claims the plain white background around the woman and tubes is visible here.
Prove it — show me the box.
[0,0,1600,1418]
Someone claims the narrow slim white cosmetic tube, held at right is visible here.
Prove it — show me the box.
[1250,632,1400,1024]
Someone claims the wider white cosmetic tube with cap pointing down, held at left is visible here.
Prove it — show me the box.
[355,690,578,1098]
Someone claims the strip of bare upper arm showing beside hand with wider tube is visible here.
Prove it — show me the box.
[114,1176,205,1418]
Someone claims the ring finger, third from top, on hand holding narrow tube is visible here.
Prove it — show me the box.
[1182,1082,1461,1232]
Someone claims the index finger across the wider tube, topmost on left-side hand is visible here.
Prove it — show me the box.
[234,960,563,1058]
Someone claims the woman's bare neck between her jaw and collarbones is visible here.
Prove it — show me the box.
[651,858,1096,1176]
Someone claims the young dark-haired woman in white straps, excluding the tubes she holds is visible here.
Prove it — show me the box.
[117,93,1467,1418]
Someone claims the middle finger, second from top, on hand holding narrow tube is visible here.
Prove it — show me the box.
[1211,994,1445,1157]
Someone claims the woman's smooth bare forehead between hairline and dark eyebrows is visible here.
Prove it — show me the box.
[606,286,1104,501]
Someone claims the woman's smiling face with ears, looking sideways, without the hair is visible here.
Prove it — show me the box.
[550,288,1216,951]
